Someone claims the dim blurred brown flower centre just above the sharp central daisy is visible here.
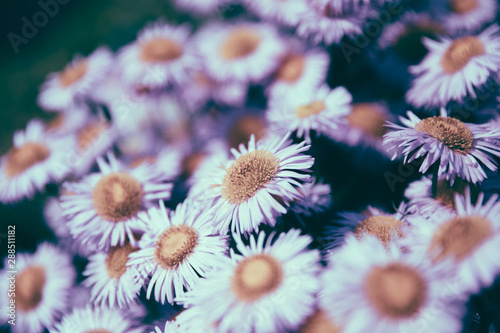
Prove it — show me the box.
[229,115,266,148]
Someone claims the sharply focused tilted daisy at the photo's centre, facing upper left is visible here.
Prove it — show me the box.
[194,134,314,234]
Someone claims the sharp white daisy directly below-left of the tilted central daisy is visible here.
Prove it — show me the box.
[127,201,228,304]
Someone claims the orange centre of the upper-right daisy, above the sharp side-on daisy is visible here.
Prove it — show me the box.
[441,36,485,73]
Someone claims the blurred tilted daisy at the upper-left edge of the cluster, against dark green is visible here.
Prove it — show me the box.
[38,47,113,112]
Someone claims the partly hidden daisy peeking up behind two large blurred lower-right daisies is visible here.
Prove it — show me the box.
[325,203,409,250]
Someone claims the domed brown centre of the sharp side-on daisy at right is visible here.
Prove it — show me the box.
[415,116,474,155]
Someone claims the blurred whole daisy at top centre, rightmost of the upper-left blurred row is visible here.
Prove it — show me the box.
[196,22,285,83]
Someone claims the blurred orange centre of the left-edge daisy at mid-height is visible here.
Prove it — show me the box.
[5,142,50,177]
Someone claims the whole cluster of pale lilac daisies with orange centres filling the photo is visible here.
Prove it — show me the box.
[0,0,500,333]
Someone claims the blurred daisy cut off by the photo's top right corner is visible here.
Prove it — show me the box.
[431,0,498,34]
